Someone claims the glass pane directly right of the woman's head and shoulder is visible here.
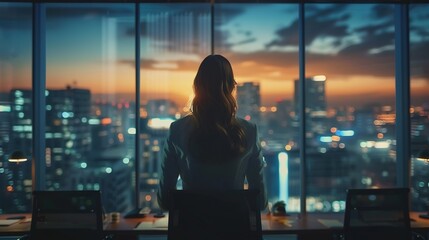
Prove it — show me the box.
[214,4,300,212]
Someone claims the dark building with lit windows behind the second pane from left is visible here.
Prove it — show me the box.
[45,87,92,190]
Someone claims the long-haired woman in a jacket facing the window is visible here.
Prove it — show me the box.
[158,55,267,210]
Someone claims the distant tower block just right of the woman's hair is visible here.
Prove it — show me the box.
[237,82,261,123]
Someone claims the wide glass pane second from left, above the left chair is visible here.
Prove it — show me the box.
[46,3,135,212]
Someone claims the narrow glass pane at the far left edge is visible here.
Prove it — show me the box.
[0,3,33,214]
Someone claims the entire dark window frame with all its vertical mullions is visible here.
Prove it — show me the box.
[1,0,417,214]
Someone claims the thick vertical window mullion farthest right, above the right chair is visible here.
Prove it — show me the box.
[395,4,411,187]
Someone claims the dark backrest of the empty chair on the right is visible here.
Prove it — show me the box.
[344,188,412,240]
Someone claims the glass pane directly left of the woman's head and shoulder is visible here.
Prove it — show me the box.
[138,3,210,208]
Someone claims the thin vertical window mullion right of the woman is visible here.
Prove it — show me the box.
[298,2,307,214]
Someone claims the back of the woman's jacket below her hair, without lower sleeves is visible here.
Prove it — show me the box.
[166,116,262,190]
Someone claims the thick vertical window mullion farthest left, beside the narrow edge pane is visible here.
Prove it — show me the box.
[32,3,46,190]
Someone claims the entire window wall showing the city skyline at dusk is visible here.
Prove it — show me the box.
[0,0,429,233]
